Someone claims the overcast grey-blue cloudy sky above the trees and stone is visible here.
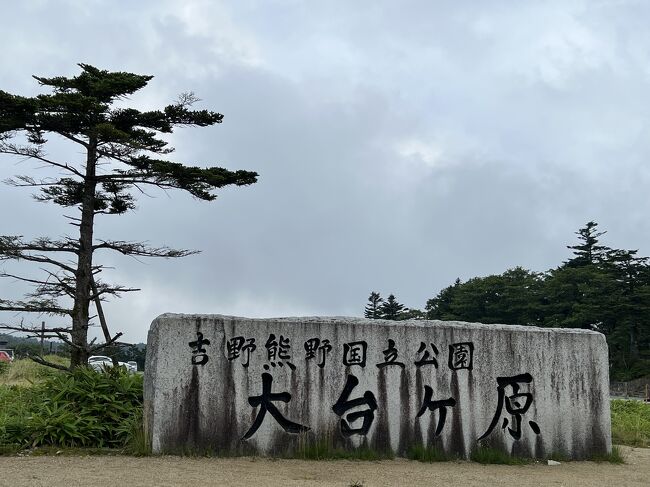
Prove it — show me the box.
[0,0,650,341]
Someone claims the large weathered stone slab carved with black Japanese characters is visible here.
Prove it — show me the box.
[145,314,611,459]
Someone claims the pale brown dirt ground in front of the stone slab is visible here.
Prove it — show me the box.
[0,447,650,487]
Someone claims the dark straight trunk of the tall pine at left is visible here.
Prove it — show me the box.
[70,136,97,368]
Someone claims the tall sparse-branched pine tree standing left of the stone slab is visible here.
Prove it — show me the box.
[0,64,257,367]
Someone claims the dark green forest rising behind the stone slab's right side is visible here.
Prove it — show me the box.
[364,221,650,380]
